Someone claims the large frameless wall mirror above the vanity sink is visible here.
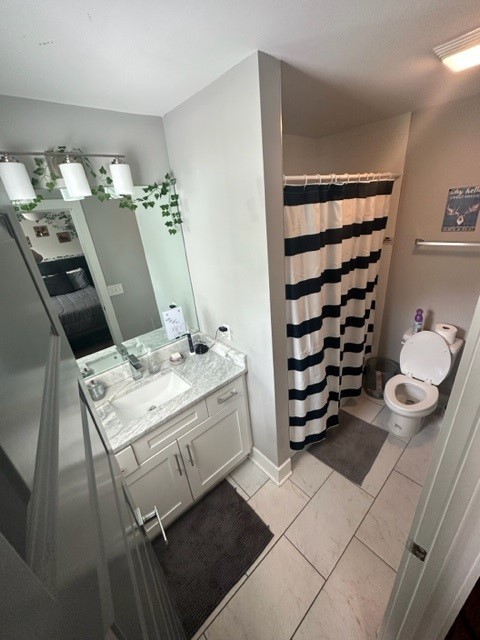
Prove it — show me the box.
[18,187,198,374]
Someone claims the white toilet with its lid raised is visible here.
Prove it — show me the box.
[383,329,463,438]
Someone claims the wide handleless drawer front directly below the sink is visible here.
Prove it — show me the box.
[132,400,208,464]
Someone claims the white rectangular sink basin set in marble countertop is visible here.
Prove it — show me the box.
[111,371,191,424]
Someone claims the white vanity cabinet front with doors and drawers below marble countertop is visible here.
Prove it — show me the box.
[116,376,252,537]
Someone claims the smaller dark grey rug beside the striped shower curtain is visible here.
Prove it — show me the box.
[308,411,388,486]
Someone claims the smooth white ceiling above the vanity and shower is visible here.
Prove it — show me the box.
[0,0,480,136]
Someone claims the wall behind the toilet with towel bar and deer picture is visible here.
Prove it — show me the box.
[381,95,480,382]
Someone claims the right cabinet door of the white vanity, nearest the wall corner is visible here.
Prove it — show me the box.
[178,400,250,498]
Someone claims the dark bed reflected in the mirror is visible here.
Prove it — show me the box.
[38,255,113,357]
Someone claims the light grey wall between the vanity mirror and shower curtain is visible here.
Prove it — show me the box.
[164,53,288,465]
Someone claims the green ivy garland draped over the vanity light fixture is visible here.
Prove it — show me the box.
[15,146,183,235]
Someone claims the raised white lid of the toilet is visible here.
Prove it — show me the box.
[400,331,452,385]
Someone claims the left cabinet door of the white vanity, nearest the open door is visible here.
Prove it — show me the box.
[127,442,193,538]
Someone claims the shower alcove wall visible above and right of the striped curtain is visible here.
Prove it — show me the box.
[284,113,411,359]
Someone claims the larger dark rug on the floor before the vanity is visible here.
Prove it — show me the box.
[153,480,273,638]
